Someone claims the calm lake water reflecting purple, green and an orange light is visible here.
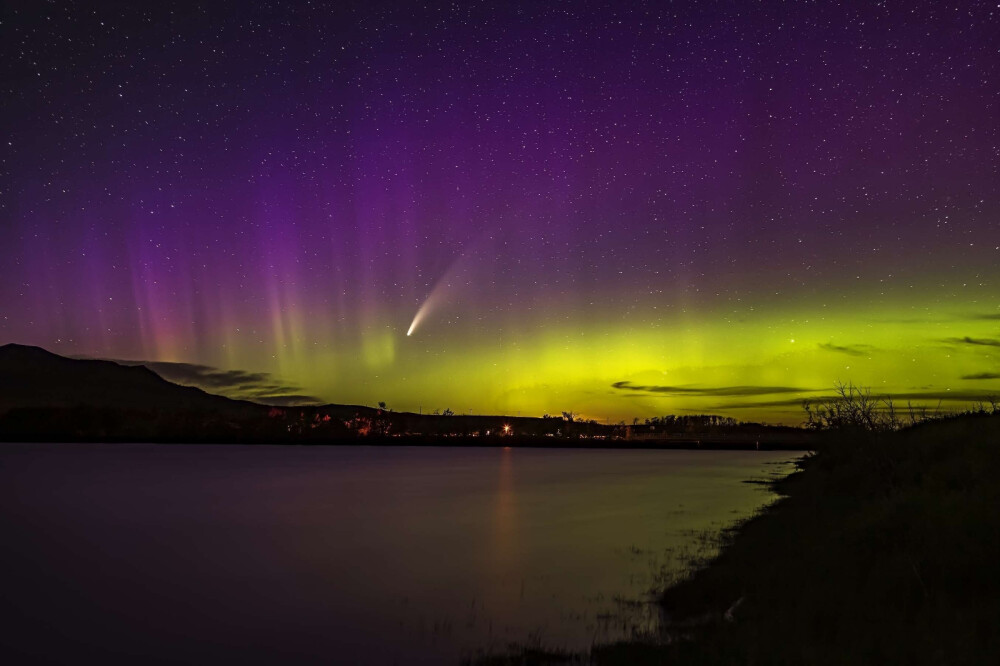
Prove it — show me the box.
[0,444,795,663]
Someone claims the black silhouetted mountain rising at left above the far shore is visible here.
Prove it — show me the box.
[0,344,263,414]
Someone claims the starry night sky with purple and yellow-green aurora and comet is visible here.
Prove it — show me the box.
[0,0,1000,423]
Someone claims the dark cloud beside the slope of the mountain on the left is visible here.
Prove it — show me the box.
[102,359,323,407]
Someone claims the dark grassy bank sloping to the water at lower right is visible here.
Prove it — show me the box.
[592,414,1000,664]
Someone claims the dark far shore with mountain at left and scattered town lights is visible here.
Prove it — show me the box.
[0,344,807,448]
